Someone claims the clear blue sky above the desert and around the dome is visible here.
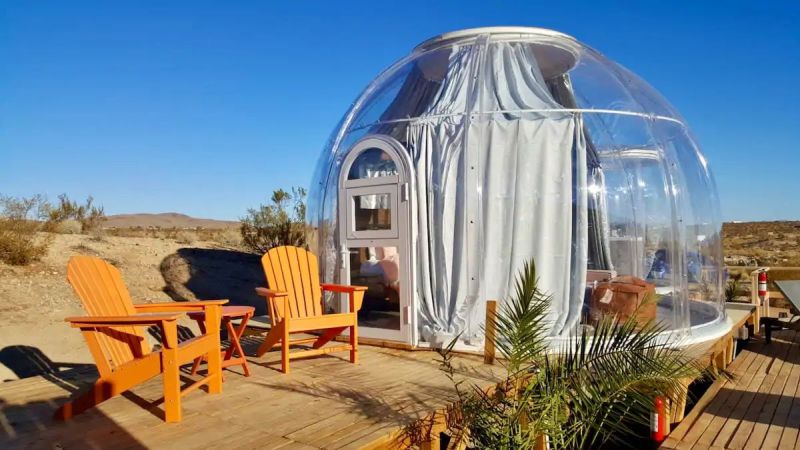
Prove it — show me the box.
[0,0,800,220]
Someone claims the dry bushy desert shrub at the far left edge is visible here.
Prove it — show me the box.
[0,195,52,265]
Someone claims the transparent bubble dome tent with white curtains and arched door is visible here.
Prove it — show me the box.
[308,27,730,347]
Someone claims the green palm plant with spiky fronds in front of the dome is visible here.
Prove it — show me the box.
[440,262,711,449]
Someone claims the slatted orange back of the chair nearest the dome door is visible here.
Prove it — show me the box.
[261,246,322,320]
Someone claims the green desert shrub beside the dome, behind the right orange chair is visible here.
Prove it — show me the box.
[239,187,306,253]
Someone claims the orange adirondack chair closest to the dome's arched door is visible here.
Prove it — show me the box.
[256,246,367,373]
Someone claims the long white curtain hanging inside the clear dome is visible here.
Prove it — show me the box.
[405,42,587,341]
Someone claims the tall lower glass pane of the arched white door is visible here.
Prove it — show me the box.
[350,247,400,330]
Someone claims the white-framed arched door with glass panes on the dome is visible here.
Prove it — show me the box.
[339,136,413,342]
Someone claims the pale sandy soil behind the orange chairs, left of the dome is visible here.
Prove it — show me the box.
[0,235,265,380]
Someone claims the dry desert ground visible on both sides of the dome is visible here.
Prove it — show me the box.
[0,220,800,380]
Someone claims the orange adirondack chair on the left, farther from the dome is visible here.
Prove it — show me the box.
[56,256,228,422]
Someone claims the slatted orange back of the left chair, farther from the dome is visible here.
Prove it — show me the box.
[67,256,149,370]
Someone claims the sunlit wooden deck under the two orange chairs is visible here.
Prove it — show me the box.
[0,338,500,449]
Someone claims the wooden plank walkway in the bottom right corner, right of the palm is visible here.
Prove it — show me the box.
[662,330,800,449]
